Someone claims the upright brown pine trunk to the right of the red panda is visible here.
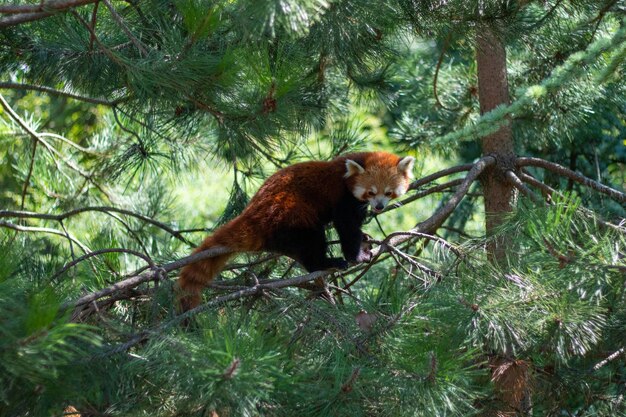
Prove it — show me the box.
[476,25,515,261]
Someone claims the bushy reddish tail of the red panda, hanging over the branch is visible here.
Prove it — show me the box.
[178,217,261,312]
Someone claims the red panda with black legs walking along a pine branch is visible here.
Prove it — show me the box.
[178,152,415,311]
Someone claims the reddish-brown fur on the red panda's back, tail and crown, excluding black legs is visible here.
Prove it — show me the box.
[179,152,408,311]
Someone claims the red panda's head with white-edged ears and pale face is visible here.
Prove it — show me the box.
[345,152,415,213]
